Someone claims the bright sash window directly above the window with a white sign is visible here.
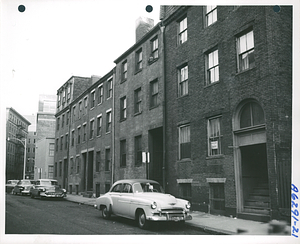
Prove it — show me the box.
[206,50,219,85]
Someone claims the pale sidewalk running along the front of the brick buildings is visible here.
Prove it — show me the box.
[65,194,291,235]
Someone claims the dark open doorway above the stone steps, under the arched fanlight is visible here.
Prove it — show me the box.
[240,143,268,203]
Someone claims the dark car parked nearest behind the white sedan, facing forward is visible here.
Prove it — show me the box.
[30,179,67,199]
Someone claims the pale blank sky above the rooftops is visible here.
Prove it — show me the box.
[1,0,159,115]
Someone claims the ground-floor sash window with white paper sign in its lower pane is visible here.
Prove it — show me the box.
[207,117,222,156]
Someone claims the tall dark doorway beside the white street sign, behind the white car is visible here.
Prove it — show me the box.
[149,127,163,185]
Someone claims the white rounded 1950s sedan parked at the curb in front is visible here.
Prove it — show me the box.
[95,179,192,229]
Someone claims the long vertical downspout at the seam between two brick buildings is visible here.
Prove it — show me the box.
[160,21,166,189]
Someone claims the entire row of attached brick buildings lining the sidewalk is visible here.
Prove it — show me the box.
[54,6,292,221]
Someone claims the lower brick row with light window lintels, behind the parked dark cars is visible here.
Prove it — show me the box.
[54,73,114,196]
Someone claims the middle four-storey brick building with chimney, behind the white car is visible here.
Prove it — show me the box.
[114,18,164,183]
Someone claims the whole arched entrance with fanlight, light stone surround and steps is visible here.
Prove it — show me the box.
[233,99,270,220]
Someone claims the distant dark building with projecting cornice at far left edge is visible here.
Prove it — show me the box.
[5,108,30,180]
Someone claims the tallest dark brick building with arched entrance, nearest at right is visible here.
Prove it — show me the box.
[161,6,292,220]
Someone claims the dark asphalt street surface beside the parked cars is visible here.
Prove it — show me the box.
[5,194,207,235]
